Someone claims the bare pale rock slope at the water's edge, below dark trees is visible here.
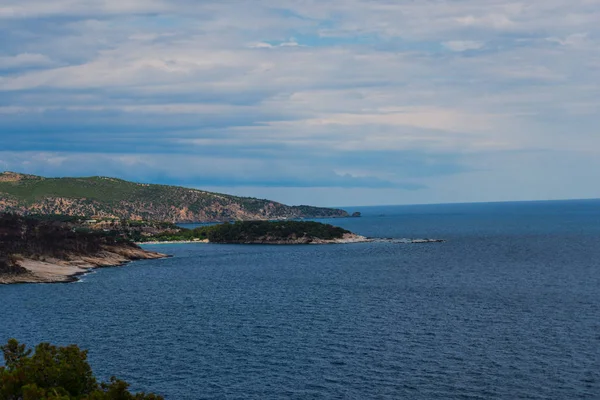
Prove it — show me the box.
[0,246,169,284]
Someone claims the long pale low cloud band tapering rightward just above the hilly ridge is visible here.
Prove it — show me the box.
[0,152,425,190]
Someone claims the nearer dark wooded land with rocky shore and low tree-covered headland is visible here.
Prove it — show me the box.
[0,213,370,284]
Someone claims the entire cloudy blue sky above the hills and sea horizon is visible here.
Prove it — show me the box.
[0,0,600,206]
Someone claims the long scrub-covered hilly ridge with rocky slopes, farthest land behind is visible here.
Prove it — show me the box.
[0,172,350,223]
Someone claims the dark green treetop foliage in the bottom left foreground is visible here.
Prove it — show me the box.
[0,339,162,400]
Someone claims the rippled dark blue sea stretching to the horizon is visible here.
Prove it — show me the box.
[0,201,600,400]
